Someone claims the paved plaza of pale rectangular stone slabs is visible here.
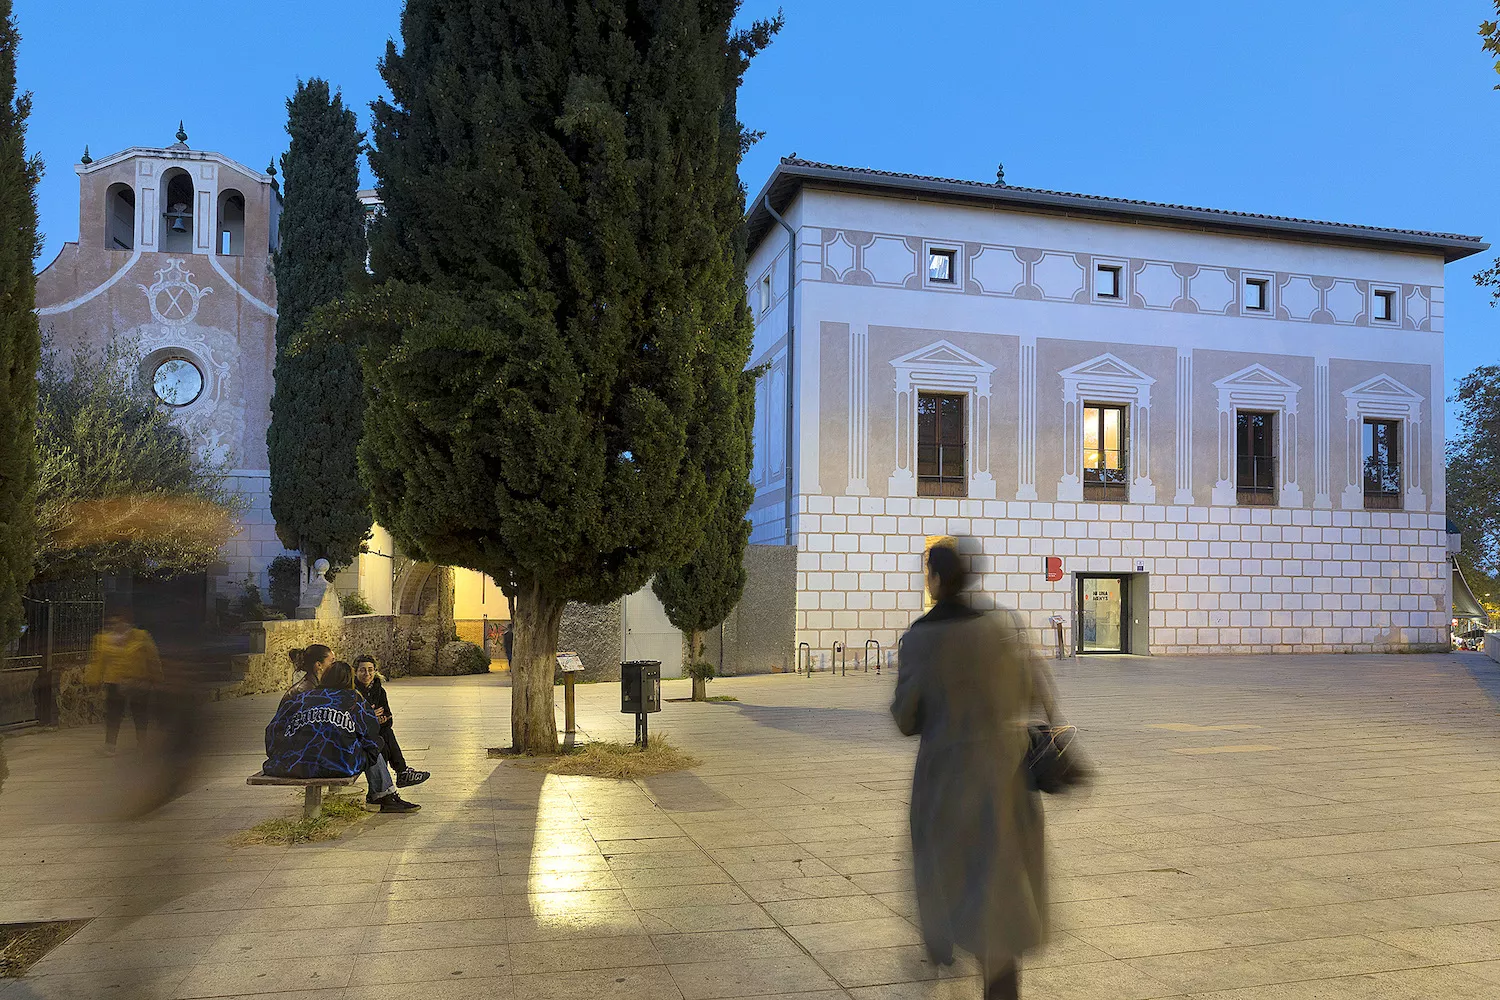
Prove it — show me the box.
[0,654,1500,1000]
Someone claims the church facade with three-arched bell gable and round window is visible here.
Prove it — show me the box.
[36,137,284,592]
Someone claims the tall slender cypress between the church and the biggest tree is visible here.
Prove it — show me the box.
[266,78,371,568]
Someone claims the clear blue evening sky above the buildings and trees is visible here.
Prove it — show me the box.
[15,0,1500,424]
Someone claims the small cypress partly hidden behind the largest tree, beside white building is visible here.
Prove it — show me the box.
[651,364,756,702]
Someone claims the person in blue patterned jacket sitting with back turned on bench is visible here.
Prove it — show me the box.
[261,660,422,813]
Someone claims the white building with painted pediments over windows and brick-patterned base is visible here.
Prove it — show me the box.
[749,160,1487,655]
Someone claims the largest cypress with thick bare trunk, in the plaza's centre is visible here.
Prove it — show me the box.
[340,0,779,753]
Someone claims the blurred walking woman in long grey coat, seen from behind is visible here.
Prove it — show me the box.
[891,544,1056,1000]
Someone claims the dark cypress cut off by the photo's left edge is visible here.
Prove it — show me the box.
[0,0,42,648]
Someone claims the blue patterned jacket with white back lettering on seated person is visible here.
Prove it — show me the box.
[261,688,384,778]
